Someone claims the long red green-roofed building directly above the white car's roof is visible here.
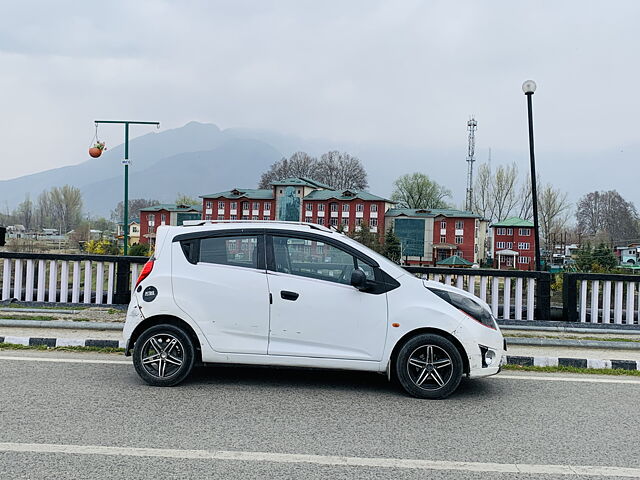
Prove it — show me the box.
[201,178,391,235]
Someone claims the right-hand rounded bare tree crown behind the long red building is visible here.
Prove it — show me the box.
[315,150,369,190]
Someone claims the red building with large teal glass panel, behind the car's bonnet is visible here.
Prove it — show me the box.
[386,208,487,265]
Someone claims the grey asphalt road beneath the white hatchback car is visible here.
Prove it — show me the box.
[0,351,640,479]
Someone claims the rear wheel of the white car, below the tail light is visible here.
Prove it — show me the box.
[133,324,196,387]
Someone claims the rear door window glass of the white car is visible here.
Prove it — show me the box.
[198,235,264,268]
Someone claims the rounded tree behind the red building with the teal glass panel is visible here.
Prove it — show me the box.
[391,172,451,208]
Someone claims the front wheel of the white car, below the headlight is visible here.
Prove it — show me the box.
[394,333,464,399]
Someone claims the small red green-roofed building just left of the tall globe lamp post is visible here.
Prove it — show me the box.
[491,217,535,270]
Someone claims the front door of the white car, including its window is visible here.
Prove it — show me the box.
[267,233,387,360]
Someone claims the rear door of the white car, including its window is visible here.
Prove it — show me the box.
[172,231,269,354]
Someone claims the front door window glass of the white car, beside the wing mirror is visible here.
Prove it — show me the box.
[273,237,375,285]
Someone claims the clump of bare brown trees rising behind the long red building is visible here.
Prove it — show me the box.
[258,150,368,190]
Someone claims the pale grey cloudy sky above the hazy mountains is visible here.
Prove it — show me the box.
[0,0,640,203]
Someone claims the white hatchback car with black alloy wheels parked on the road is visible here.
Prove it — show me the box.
[124,221,506,398]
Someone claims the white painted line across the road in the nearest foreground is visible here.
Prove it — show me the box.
[0,443,640,478]
